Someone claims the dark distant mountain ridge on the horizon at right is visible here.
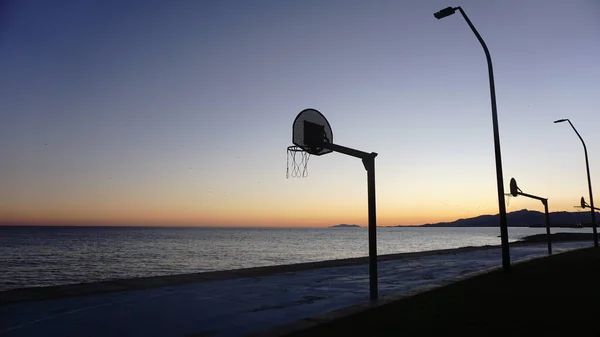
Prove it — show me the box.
[419,209,600,227]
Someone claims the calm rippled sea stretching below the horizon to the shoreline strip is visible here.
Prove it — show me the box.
[0,227,590,290]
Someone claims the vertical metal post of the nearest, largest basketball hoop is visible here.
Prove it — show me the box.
[362,153,378,300]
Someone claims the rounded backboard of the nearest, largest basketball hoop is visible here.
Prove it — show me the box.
[292,109,333,156]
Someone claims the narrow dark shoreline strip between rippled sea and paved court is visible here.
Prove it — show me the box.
[0,233,592,306]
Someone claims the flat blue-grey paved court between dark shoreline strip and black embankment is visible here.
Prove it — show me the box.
[0,241,591,336]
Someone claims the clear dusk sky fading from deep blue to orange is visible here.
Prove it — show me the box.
[0,0,600,226]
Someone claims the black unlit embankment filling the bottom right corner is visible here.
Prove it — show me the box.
[278,244,600,337]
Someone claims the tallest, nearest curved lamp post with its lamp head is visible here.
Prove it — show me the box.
[433,7,511,273]
